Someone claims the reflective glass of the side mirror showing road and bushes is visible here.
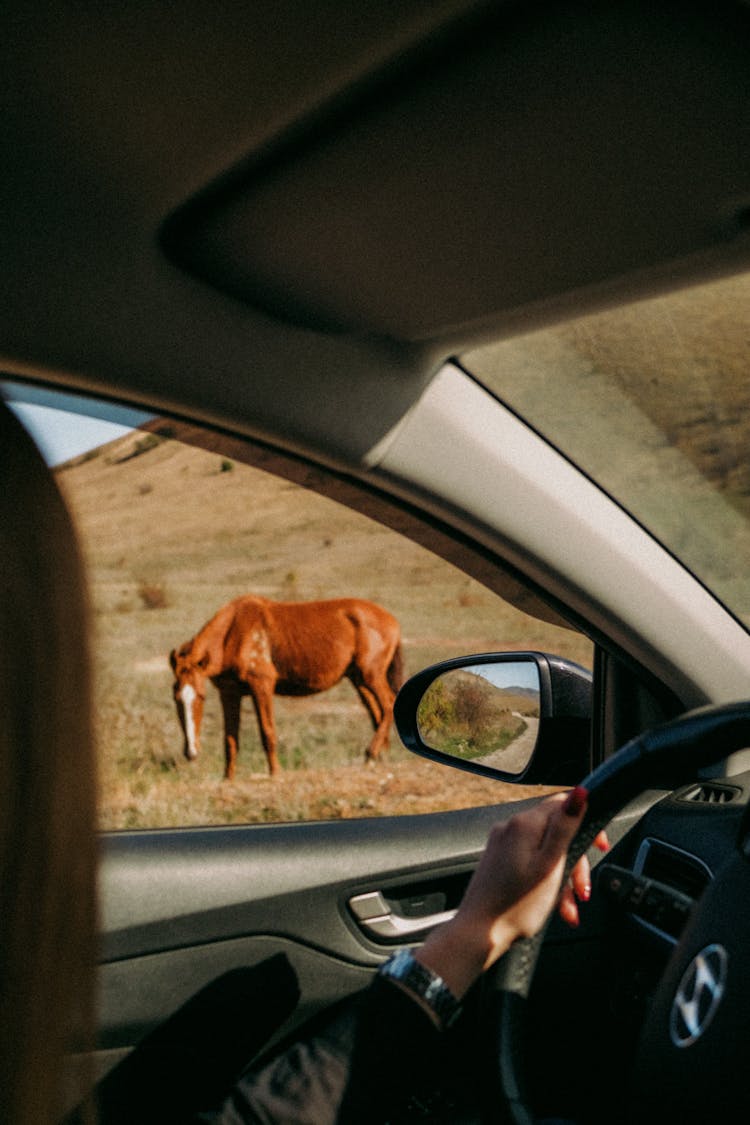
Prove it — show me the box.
[417,659,540,774]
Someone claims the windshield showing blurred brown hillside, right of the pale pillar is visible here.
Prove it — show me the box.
[461,268,750,626]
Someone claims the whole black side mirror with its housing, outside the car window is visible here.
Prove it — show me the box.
[394,653,591,785]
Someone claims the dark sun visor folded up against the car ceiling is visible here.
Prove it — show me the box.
[165,2,750,342]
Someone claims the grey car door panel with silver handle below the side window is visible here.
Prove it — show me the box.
[93,802,642,1051]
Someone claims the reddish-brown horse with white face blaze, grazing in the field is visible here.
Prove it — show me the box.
[170,594,403,780]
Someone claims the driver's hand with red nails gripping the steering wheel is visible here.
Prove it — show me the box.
[415,788,609,999]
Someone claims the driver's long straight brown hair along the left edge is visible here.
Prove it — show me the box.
[0,402,96,1125]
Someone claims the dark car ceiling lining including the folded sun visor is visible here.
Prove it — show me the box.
[0,0,750,465]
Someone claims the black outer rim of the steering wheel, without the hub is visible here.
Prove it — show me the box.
[487,701,750,1125]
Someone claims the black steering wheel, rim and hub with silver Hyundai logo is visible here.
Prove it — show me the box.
[488,702,750,1125]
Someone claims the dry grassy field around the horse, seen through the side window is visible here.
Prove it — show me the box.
[58,434,590,828]
